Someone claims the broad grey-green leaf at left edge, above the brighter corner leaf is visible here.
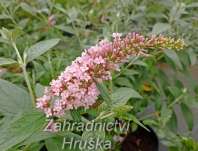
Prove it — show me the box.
[0,80,32,116]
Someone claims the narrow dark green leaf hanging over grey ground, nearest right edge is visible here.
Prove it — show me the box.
[180,103,194,130]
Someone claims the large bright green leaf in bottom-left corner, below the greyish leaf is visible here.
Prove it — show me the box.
[0,110,45,151]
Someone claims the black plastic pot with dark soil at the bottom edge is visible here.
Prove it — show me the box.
[121,127,159,151]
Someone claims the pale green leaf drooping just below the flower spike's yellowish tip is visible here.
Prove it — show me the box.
[164,49,183,70]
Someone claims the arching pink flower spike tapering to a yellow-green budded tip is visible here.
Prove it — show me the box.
[37,33,184,117]
